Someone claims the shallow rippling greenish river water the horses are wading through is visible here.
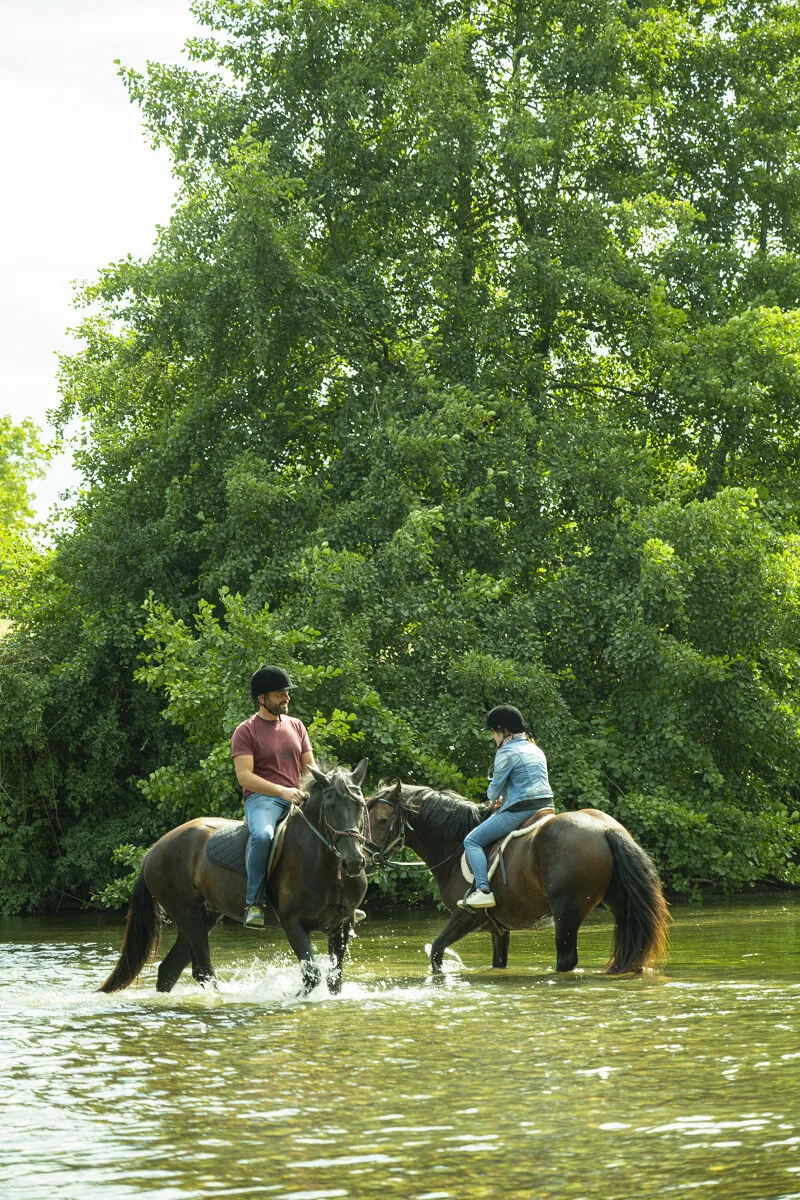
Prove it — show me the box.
[0,893,800,1200]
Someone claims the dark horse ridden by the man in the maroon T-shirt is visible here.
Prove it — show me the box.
[98,758,369,992]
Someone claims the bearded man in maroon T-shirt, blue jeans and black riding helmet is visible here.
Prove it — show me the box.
[230,666,315,929]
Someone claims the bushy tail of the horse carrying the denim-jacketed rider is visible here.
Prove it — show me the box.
[606,829,670,974]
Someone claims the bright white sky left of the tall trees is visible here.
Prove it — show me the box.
[0,0,203,516]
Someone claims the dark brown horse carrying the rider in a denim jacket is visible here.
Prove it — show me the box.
[367,784,669,974]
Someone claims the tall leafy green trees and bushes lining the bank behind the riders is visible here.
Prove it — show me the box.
[0,0,800,911]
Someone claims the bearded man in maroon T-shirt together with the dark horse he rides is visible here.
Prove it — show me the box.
[100,666,369,994]
